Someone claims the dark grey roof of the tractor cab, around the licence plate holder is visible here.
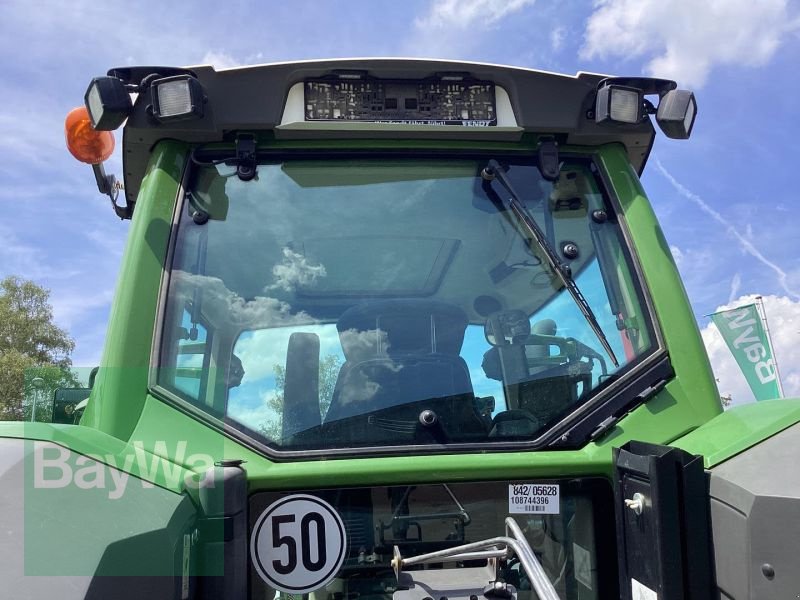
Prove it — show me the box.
[117,58,655,202]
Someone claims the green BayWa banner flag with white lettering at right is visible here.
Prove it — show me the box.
[711,304,780,400]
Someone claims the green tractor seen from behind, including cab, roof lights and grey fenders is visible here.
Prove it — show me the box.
[0,59,800,600]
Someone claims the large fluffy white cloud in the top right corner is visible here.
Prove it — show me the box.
[581,0,800,86]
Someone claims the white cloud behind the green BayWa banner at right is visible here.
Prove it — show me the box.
[700,294,800,404]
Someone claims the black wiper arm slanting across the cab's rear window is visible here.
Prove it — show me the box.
[481,159,619,367]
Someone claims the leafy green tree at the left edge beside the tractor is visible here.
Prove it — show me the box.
[0,276,78,420]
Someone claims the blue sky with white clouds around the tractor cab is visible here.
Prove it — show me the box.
[0,0,800,403]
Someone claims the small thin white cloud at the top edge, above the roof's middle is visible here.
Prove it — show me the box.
[414,0,535,30]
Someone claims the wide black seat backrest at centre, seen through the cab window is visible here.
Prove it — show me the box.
[325,299,474,422]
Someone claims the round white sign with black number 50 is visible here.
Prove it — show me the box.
[250,494,347,594]
